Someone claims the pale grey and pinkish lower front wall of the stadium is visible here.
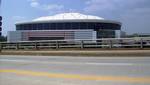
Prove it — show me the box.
[8,30,96,42]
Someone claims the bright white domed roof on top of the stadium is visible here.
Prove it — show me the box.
[33,13,104,21]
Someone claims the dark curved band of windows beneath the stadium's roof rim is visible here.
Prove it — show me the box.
[16,22,120,30]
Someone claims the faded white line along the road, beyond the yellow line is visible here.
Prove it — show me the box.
[0,59,143,66]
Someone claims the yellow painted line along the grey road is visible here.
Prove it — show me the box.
[0,69,150,83]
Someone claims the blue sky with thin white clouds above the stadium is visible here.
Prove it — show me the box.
[0,0,150,36]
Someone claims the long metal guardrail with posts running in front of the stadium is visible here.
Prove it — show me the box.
[0,37,150,50]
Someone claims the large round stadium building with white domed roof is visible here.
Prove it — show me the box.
[8,13,121,42]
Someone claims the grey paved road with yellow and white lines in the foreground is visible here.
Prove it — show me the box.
[0,55,150,85]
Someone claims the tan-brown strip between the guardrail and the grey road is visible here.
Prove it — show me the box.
[0,49,150,57]
